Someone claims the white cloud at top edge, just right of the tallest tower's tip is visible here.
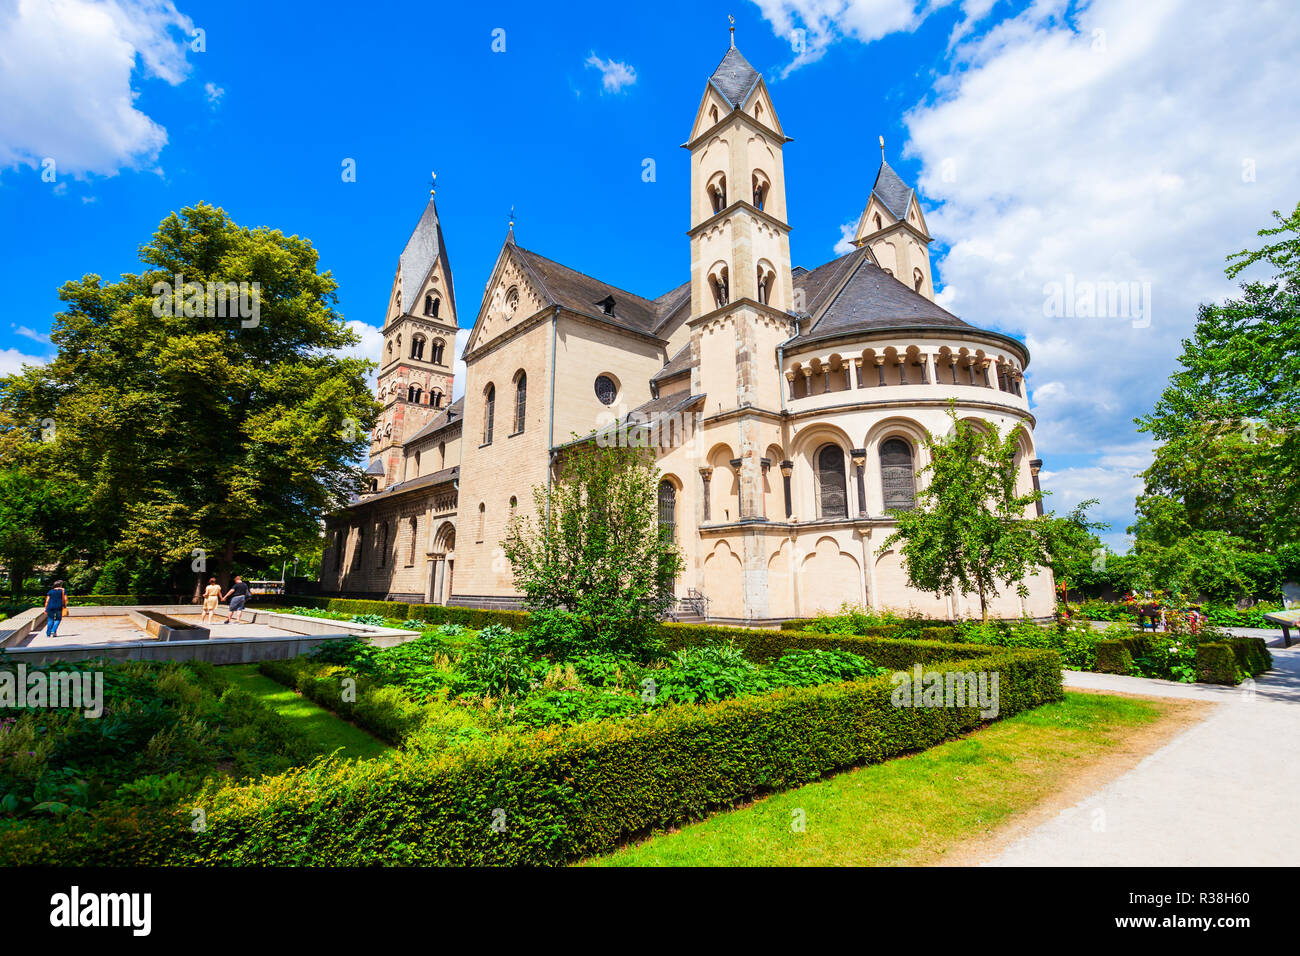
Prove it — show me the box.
[754,0,951,78]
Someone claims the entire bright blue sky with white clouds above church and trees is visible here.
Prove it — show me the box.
[0,0,1300,548]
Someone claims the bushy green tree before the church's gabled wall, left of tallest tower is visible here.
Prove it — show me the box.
[502,444,681,658]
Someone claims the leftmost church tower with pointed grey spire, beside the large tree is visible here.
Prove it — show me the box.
[367,183,456,490]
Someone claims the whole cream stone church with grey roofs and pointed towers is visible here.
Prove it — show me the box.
[321,42,1054,624]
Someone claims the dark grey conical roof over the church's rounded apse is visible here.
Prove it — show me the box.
[794,248,975,345]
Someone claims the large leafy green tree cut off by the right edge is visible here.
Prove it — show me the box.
[1135,206,1300,553]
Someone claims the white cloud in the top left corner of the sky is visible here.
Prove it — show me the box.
[0,0,192,176]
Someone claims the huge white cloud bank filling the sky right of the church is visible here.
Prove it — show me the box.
[905,0,1300,531]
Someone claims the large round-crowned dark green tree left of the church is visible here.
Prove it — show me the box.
[0,203,376,595]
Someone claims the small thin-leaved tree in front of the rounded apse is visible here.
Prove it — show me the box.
[878,403,1052,620]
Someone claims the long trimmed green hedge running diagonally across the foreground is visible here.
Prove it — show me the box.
[0,626,1063,866]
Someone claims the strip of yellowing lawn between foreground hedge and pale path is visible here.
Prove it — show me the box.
[585,693,1178,866]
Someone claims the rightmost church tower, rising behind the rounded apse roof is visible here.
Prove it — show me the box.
[853,146,935,302]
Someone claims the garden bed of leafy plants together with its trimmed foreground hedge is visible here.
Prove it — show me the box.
[0,626,1062,865]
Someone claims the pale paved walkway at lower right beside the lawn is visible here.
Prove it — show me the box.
[984,641,1300,866]
